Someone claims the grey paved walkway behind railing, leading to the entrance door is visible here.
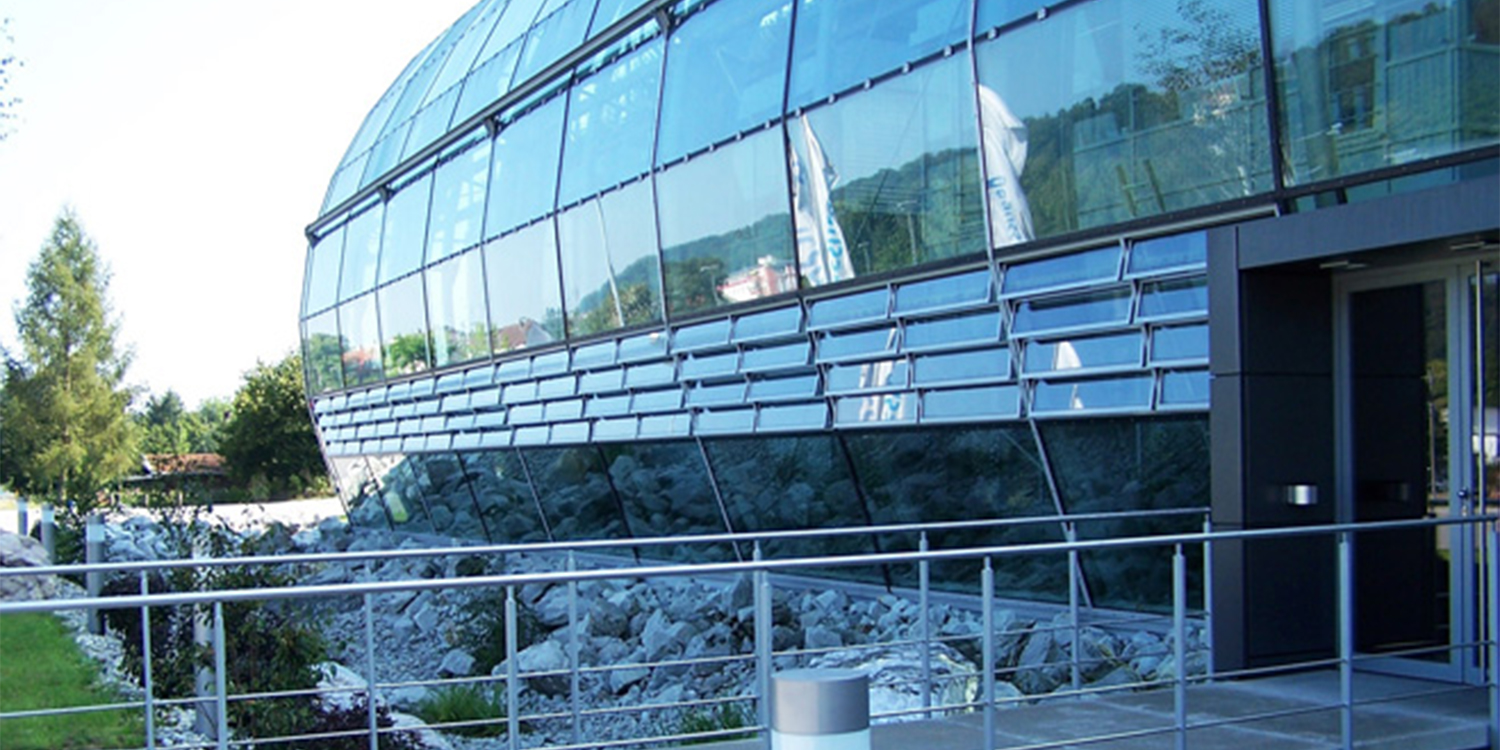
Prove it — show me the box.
[710,671,1490,750]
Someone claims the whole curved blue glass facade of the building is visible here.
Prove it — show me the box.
[302,0,1500,603]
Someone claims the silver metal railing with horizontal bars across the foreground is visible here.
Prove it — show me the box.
[0,509,1500,750]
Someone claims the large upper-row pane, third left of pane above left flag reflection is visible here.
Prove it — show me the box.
[485,96,566,237]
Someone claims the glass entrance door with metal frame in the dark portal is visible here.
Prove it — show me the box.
[1337,260,1500,681]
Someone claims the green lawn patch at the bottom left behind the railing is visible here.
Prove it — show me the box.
[0,614,146,750]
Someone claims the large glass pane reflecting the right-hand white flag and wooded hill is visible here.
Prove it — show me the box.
[978,0,1272,237]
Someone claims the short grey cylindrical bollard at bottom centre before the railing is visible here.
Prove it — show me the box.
[771,669,870,750]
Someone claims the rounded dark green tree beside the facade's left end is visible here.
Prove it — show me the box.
[219,354,329,497]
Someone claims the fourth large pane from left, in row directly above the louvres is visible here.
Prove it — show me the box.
[426,251,489,368]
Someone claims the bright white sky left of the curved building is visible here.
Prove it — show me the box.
[0,0,474,407]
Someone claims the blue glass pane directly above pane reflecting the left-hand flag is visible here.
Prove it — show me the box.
[788,0,969,108]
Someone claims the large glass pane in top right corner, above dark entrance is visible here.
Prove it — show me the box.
[1271,0,1500,183]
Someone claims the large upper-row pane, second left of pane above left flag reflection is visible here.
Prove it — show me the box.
[558,39,662,206]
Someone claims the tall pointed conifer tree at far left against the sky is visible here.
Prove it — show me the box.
[0,210,140,510]
